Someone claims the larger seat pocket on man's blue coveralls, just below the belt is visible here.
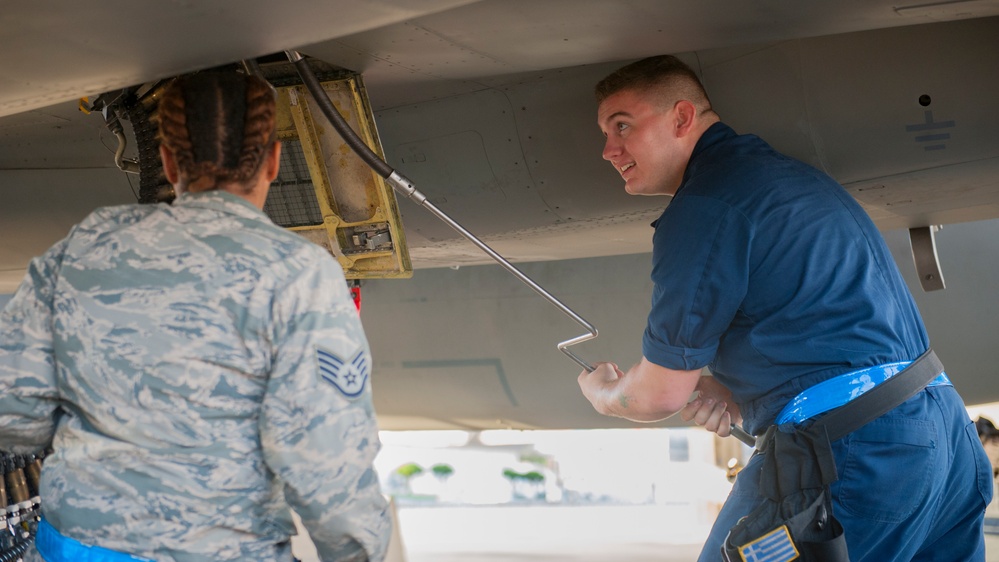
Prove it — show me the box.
[833,417,938,523]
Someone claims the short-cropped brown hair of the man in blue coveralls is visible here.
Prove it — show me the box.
[595,55,711,113]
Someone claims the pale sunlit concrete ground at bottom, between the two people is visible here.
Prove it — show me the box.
[296,505,999,562]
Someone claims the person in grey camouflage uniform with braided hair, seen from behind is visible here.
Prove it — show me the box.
[0,73,391,562]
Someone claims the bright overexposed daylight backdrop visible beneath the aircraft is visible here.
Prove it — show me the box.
[296,404,999,562]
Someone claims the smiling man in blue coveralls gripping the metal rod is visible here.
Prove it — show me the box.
[579,56,992,562]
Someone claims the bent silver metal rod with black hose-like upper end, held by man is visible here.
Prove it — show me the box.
[285,51,756,447]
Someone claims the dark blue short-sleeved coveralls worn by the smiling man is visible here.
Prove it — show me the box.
[643,123,992,562]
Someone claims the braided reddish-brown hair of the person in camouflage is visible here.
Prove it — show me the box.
[158,72,276,192]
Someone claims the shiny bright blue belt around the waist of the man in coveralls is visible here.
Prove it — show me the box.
[776,361,953,425]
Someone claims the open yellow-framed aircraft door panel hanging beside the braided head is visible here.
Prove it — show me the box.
[264,74,413,279]
